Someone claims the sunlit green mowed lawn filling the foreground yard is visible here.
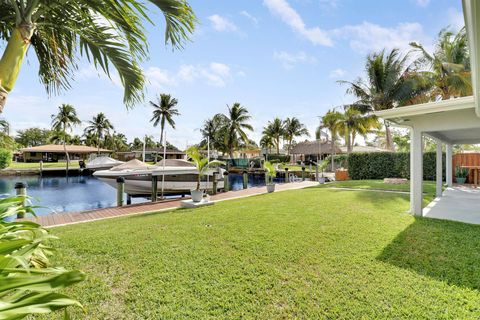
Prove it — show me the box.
[43,188,480,319]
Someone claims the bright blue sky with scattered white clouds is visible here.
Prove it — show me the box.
[0,0,464,148]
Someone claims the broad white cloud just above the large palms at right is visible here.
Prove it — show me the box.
[332,22,432,54]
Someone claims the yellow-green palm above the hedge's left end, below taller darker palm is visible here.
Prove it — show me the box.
[337,105,379,154]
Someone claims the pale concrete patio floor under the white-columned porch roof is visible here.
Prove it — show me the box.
[423,186,480,224]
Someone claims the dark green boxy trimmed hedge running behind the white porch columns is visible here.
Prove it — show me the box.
[348,152,445,180]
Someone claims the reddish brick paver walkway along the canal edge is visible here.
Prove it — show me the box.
[28,181,318,227]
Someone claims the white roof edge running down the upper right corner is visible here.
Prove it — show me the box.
[462,0,480,117]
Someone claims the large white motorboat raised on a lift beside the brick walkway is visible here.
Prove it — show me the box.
[93,159,225,196]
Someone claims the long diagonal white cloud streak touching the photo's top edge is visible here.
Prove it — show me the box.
[263,0,333,46]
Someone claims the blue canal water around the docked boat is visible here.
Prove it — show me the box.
[0,174,278,215]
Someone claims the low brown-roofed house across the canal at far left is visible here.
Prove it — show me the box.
[20,144,111,162]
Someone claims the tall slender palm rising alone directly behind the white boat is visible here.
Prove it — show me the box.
[150,93,180,146]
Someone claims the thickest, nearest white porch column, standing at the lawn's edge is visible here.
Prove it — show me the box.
[410,128,423,217]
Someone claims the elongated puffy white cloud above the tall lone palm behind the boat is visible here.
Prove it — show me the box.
[145,62,232,89]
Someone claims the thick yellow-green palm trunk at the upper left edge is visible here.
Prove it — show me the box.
[0,24,34,113]
